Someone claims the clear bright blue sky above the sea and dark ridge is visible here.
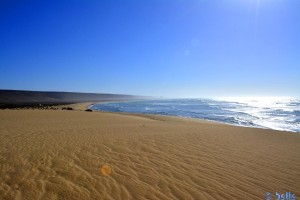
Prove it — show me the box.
[0,0,300,97]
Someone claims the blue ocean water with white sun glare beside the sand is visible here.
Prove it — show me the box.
[90,97,300,132]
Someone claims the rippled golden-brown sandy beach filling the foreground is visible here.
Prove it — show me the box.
[0,108,300,200]
